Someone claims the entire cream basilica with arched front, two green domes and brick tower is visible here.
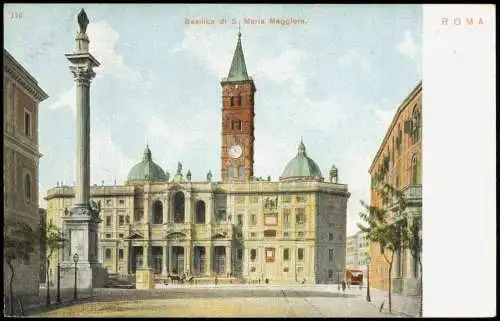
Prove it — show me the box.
[45,34,350,283]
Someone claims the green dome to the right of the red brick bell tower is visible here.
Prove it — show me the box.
[280,140,323,181]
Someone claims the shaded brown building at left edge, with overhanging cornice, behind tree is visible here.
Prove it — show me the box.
[3,49,48,298]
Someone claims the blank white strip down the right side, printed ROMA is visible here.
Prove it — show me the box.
[422,5,496,317]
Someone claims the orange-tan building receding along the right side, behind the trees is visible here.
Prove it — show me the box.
[369,82,422,294]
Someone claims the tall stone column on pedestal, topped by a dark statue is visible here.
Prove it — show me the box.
[61,9,105,288]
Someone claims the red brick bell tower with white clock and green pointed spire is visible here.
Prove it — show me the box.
[221,32,257,183]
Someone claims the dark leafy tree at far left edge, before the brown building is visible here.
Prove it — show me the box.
[3,216,40,315]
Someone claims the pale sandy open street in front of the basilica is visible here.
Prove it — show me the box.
[28,285,400,317]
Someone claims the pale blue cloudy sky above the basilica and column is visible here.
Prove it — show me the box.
[4,4,422,235]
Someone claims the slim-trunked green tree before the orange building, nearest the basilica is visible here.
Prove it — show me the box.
[357,184,406,312]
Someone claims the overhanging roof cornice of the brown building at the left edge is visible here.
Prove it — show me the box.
[3,49,49,102]
